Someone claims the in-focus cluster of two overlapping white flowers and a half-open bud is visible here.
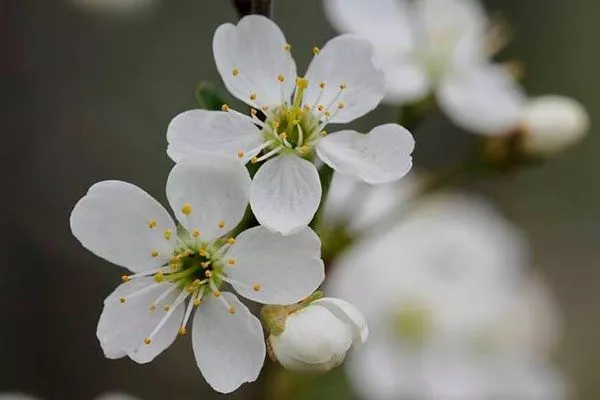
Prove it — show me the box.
[70,16,414,393]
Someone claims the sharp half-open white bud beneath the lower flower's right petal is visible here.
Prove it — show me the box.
[269,297,369,371]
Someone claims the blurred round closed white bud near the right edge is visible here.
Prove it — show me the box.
[521,96,590,156]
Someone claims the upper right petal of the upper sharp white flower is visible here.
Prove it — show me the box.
[304,35,385,123]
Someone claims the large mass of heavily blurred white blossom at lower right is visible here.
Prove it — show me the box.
[328,195,565,400]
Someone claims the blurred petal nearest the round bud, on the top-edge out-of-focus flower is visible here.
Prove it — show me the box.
[438,65,523,135]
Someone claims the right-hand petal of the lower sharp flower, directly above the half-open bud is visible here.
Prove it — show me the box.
[227,226,325,304]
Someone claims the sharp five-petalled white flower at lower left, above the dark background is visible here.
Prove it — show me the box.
[70,155,324,393]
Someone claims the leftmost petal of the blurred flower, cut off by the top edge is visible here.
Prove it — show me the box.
[323,0,412,53]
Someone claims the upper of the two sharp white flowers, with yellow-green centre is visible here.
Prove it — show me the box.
[167,15,414,235]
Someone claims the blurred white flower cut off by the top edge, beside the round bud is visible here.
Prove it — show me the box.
[324,0,523,135]
